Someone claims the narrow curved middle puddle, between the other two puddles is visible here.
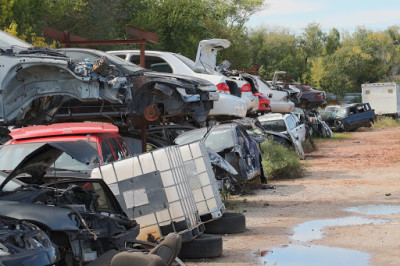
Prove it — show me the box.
[292,216,390,241]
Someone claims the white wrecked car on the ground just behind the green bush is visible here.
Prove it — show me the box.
[258,113,306,160]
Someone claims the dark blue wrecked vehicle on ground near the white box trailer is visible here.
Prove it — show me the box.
[320,103,376,131]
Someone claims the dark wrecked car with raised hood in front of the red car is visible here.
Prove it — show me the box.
[0,141,139,265]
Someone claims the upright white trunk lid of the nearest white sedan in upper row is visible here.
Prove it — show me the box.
[195,39,231,74]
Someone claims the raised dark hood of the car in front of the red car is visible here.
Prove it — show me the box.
[0,140,101,191]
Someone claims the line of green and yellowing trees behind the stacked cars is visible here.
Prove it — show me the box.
[0,0,400,96]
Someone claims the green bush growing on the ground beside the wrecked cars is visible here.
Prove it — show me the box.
[261,141,304,179]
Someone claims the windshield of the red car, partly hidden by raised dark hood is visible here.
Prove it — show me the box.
[0,142,97,172]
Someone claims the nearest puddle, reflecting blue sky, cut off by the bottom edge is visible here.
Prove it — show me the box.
[261,245,369,266]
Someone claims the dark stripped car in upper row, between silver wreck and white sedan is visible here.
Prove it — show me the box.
[56,48,219,125]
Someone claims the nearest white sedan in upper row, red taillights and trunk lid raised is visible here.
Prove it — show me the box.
[108,42,259,117]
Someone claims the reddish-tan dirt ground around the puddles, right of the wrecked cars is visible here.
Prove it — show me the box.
[187,128,400,265]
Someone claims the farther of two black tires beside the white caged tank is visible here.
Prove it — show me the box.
[204,212,246,234]
